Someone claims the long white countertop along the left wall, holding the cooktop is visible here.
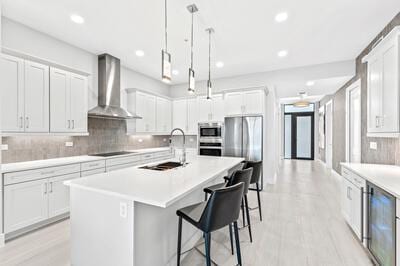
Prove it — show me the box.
[0,147,169,173]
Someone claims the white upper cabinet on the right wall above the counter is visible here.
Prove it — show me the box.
[363,27,400,137]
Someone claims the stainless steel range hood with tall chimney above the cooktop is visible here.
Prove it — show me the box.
[88,54,142,120]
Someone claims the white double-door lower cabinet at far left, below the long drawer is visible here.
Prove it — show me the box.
[4,173,80,233]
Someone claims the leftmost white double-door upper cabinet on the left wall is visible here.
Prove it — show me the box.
[0,55,49,133]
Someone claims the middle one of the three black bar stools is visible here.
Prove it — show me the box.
[204,168,253,243]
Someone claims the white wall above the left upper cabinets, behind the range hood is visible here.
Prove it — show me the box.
[2,17,169,108]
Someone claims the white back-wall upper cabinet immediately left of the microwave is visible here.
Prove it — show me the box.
[172,98,198,135]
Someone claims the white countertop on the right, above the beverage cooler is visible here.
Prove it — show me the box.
[341,163,400,198]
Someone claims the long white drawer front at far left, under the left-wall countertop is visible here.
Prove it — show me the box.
[4,164,81,186]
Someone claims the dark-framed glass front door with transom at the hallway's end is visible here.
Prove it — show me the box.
[284,104,314,160]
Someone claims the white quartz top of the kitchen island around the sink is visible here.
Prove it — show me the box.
[65,156,244,208]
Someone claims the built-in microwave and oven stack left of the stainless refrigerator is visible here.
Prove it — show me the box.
[198,123,224,156]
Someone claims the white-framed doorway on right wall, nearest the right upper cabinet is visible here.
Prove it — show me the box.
[346,80,361,163]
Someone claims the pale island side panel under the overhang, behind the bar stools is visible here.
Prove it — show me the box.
[134,173,227,266]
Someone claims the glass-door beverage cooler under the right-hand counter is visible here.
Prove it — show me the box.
[367,183,396,266]
